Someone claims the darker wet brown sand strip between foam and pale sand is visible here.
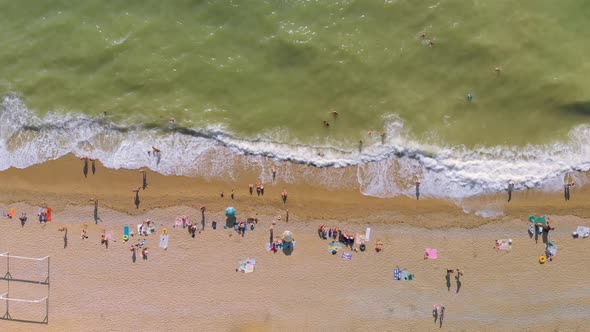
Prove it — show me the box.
[0,155,590,228]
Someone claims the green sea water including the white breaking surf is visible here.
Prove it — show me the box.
[0,0,590,196]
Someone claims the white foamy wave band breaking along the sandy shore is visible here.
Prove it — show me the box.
[0,95,590,199]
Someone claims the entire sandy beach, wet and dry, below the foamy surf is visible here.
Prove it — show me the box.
[0,156,590,331]
